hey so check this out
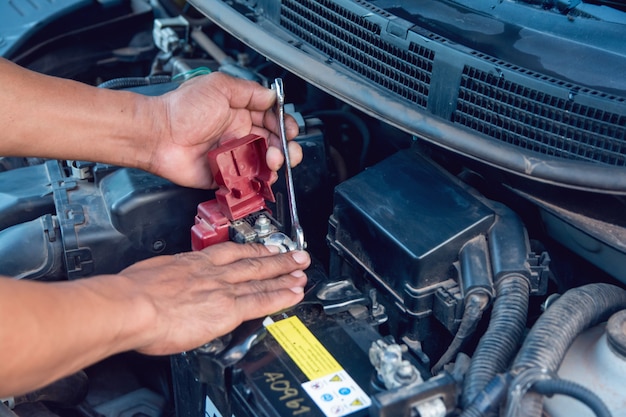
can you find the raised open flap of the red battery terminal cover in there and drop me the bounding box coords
[208,134,275,220]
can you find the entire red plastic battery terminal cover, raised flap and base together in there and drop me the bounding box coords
[191,134,275,250]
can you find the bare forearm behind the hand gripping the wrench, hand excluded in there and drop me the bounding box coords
[0,59,162,168]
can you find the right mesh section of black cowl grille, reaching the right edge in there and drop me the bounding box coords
[453,66,626,166]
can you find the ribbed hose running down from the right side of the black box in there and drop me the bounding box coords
[461,274,530,409]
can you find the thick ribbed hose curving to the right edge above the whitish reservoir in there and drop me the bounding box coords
[512,283,626,417]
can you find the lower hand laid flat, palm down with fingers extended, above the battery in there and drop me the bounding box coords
[120,242,310,355]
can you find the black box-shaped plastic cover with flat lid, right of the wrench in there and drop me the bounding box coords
[329,150,494,302]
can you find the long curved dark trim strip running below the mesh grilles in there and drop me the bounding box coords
[190,0,626,194]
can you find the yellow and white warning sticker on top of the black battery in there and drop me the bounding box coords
[264,316,371,417]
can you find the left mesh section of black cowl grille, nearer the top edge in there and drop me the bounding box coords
[280,0,434,108]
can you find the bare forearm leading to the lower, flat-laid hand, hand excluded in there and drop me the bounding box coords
[0,276,153,398]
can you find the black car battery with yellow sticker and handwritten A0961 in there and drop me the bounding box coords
[201,303,380,417]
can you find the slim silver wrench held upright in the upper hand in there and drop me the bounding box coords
[272,78,306,250]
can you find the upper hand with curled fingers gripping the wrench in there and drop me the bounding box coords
[148,72,302,188]
